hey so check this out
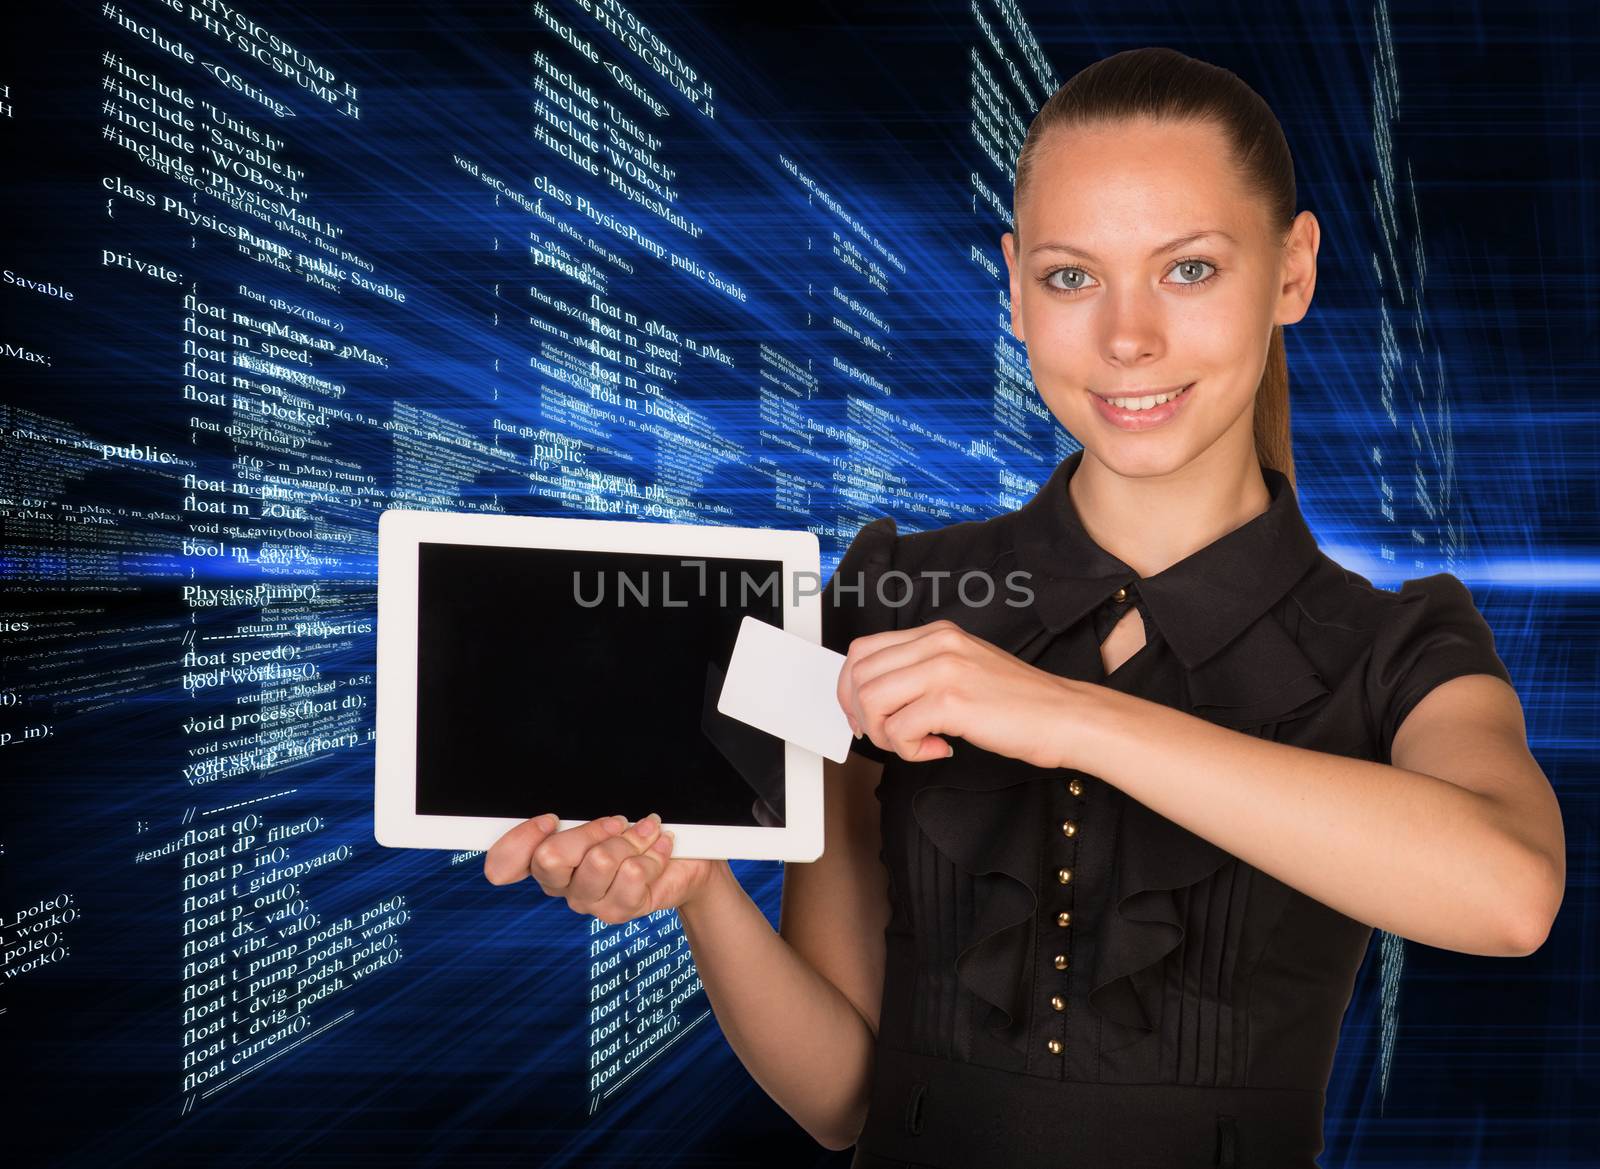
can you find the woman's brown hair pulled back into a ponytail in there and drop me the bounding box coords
[1011,46,1294,485]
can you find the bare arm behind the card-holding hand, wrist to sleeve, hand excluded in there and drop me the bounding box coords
[1067,675,1566,956]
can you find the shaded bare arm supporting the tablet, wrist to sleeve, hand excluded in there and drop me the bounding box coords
[678,753,890,1150]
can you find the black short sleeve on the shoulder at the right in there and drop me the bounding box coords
[1368,573,1510,763]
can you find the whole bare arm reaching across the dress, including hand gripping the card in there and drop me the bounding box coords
[838,619,1566,956]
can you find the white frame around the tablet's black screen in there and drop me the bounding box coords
[373,509,822,862]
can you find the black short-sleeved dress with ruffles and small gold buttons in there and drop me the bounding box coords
[822,451,1510,1169]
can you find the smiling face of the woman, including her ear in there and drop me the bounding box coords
[1000,120,1318,475]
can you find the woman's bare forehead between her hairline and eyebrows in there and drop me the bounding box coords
[1018,120,1256,251]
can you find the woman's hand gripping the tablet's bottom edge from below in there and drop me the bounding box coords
[483,812,728,924]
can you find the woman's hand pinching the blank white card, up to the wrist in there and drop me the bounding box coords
[838,619,1085,768]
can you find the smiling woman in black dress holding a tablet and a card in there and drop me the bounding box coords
[485,48,1565,1169]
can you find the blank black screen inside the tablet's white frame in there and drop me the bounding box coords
[416,542,792,827]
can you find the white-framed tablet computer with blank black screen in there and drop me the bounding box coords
[373,509,822,862]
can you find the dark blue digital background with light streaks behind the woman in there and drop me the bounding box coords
[0,0,1600,1166]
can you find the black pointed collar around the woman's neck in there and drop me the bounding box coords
[1016,449,1318,670]
